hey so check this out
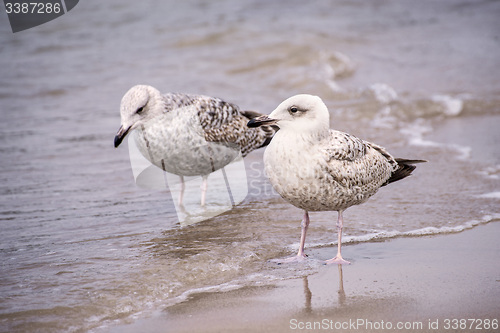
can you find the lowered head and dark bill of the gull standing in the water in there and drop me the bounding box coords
[115,85,164,148]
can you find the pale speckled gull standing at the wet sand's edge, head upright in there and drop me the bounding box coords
[248,94,425,264]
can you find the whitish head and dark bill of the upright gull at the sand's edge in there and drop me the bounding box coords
[248,94,330,133]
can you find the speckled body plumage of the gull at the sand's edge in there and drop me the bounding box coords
[264,130,398,211]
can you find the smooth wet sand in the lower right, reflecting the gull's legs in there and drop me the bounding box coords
[110,222,500,333]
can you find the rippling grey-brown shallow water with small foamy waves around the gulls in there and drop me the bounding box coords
[0,0,500,332]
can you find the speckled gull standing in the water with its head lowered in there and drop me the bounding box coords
[114,85,276,206]
